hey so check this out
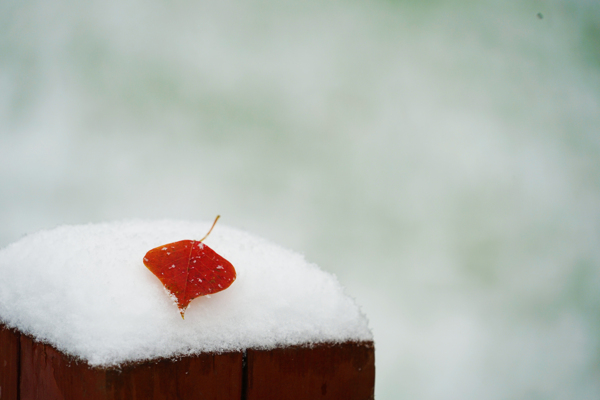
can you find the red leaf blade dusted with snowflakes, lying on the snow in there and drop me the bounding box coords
[144,241,236,318]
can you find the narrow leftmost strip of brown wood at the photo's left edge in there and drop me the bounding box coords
[0,324,20,400]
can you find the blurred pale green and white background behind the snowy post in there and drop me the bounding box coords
[0,0,600,400]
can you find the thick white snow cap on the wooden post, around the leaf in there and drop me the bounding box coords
[0,221,372,366]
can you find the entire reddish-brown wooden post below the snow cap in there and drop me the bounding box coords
[0,325,375,400]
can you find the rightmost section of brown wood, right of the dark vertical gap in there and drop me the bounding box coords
[245,342,375,400]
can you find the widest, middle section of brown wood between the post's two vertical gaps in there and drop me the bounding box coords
[20,336,243,400]
